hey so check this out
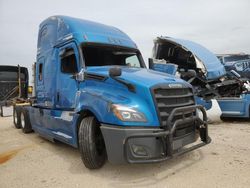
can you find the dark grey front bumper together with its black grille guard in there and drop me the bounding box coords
[101,105,211,164]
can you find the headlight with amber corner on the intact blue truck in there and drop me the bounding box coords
[111,104,147,122]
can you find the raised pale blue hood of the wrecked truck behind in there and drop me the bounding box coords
[159,37,226,80]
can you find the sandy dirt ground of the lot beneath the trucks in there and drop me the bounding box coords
[0,117,250,188]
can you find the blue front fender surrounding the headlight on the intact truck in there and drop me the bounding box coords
[76,76,159,126]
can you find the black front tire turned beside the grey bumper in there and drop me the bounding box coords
[78,116,106,169]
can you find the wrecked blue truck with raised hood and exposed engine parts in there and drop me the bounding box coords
[149,37,249,117]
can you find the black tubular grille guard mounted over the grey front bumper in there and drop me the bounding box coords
[123,105,211,163]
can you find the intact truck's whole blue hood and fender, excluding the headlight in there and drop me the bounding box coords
[73,66,192,126]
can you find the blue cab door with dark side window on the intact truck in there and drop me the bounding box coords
[56,42,79,110]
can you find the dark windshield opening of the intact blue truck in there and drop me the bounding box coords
[82,46,145,68]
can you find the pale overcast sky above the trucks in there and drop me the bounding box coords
[0,0,250,71]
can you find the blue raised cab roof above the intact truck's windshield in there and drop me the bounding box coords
[38,16,137,53]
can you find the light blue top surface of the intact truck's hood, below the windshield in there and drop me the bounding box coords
[87,66,192,88]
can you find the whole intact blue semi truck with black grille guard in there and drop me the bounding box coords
[13,16,211,169]
